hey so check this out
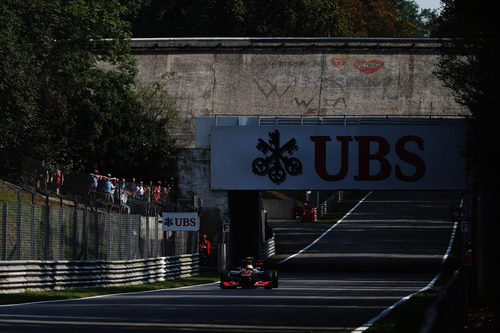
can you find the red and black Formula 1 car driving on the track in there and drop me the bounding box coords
[220,258,278,289]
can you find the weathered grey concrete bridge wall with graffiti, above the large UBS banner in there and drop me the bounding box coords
[132,38,468,148]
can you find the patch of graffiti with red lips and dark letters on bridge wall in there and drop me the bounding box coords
[253,55,393,116]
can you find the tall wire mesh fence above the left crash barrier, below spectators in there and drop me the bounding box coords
[0,198,198,261]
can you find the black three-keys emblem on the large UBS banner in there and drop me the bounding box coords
[252,130,302,185]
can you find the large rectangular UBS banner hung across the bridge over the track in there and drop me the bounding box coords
[210,120,465,190]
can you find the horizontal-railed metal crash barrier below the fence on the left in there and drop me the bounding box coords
[0,254,199,293]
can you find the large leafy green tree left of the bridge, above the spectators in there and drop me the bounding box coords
[0,0,179,176]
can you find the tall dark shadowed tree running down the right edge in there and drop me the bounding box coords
[437,0,500,315]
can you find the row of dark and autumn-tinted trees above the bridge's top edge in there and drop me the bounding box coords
[133,0,434,37]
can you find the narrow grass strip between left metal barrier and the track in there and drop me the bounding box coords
[0,269,220,305]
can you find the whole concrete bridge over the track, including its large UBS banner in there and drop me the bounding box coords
[132,38,469,264]
